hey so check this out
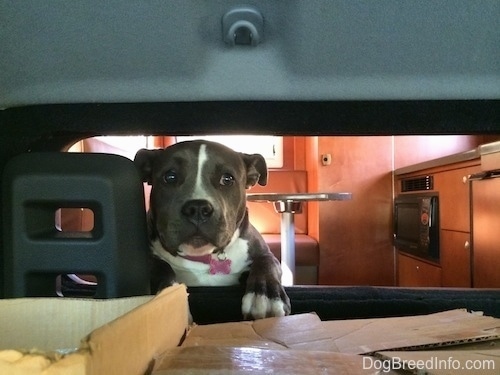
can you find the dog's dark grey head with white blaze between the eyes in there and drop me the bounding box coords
[134,141,267,256]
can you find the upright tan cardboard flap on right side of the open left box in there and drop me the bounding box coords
[84,284,189,375]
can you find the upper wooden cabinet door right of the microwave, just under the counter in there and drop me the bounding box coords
[434,166,479,232]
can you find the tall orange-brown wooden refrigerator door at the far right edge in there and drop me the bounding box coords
[472,178,500,288]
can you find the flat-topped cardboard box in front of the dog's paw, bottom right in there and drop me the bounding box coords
[153,310,500,375]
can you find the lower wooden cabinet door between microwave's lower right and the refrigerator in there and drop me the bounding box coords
[440,230,472,288]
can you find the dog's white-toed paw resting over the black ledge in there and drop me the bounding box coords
[241,291,290,320]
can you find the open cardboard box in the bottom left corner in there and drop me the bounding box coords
[0,285,188,375]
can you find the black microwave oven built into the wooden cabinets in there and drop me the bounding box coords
[394,193,439,262]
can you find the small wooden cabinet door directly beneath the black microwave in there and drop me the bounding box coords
[398,253,441,287]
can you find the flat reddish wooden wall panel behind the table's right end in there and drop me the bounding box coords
[311,137,395,285]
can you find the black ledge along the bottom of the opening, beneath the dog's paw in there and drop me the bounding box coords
[188,286,500,324]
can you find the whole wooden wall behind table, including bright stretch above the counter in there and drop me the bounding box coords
[305,135,500,285]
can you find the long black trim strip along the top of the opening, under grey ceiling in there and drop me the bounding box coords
[0,100,500,142]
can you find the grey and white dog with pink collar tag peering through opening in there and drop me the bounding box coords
[134,140,291,319]
